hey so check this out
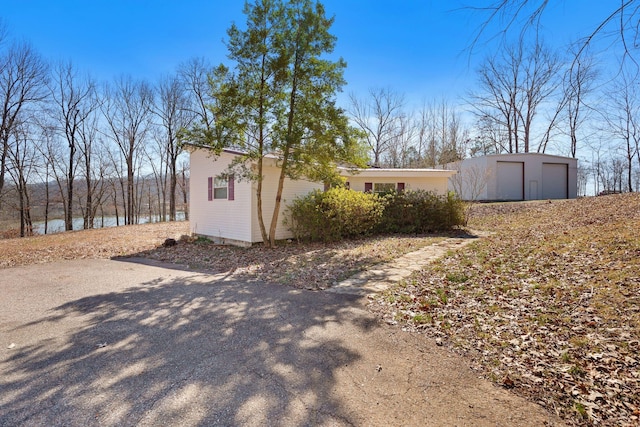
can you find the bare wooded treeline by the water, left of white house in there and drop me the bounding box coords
[0,26,216,236]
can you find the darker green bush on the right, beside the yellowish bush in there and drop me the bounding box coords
[376,190,464,234]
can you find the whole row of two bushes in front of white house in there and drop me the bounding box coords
[287,188,464,242]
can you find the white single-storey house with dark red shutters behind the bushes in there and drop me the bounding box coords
[189,147,456,246]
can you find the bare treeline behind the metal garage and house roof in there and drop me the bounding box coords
[349,39,640,195]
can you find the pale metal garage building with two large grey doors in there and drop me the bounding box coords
[445,153,578,201]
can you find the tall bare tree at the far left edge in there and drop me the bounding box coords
[0,43,48,212]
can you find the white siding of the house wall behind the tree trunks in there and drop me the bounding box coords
[251,165,324,243]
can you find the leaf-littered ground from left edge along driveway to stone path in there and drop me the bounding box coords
[0,222,444,289]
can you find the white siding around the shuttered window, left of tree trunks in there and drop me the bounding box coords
[189,149,253,243]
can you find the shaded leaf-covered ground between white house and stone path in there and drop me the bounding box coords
[142,236,443,289]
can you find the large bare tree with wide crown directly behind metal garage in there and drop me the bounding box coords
[470,43,560,153]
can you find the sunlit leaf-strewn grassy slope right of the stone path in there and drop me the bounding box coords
[370,194,640,426]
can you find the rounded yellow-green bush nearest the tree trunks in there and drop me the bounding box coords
[287,188,384,242]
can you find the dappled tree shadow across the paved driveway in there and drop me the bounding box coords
[0,261,373,426]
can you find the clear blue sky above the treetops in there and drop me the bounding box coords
[0,0,611,105]
